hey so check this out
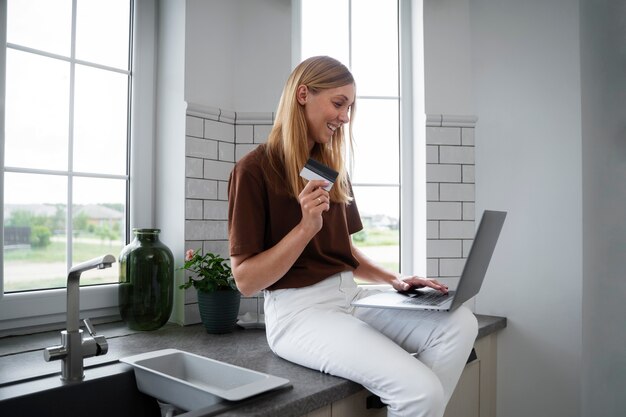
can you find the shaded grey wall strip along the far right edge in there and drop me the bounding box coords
[580,0,626,416]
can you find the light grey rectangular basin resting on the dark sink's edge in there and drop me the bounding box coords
[120,349,289,411]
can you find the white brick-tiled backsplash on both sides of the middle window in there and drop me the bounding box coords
[185,105,476,324]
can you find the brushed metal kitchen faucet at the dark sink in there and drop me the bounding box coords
[43,255,115,381]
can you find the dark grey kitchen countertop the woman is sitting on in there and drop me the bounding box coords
[0,315,506,417]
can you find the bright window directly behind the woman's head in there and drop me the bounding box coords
[300,0,405,271]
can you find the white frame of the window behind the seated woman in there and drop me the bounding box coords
[291,0,426,277]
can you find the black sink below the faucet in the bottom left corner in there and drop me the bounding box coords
[0,362,161,417]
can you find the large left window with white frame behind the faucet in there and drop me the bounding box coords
[0,0,156,332]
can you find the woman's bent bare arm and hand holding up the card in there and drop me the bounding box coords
[230,180,330,296]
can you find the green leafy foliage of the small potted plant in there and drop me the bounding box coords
[179,249,237,292]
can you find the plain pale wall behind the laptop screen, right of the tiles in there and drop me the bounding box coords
[466,0,582,417]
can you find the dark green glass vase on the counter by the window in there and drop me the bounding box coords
[119,229,174,330]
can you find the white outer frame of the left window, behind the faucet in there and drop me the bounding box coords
[0,0,158,336]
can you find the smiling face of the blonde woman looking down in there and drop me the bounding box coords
[297,84,356,150]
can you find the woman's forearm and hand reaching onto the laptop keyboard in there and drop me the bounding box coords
[352,244,448,294]
